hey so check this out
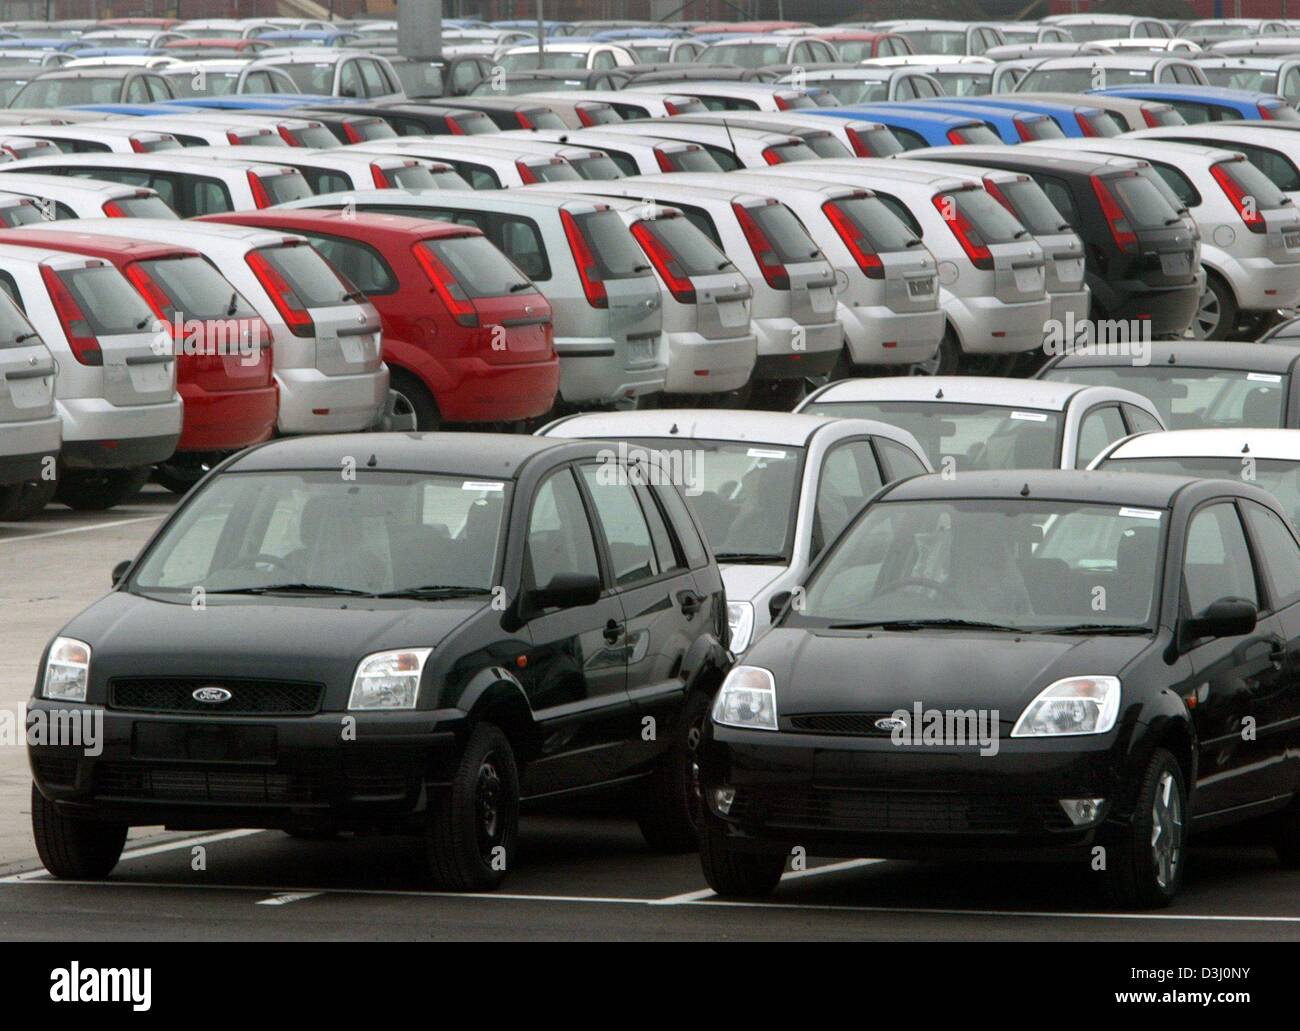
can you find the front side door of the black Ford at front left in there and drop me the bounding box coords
[517,467,633,797]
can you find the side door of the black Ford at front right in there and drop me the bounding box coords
[1182,499,1286,818]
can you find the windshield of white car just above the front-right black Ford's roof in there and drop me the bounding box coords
[801,400,1061,471]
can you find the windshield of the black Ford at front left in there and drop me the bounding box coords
[131,469,507,595]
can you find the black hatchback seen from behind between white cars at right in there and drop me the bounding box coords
[913,147,1201,337]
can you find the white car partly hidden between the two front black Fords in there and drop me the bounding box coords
[538,410,931,655]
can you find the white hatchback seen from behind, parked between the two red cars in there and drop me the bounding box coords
[38,219,389,434]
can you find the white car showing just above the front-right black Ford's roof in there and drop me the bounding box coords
[796,376,1165,475]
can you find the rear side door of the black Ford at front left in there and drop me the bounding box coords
[579,456,705,772]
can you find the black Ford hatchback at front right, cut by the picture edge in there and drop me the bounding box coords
[699,471,1300,906]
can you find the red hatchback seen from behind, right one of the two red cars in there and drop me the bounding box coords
[202,209,560,429]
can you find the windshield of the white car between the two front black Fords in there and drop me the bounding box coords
[637,438,803,566]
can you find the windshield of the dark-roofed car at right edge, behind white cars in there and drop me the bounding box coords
[1044,364,1288,429]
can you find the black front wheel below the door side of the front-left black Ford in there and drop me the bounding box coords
[425,723,519,892]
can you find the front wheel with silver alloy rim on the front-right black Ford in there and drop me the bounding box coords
[1102,749,1188,909]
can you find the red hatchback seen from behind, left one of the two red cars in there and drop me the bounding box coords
[4,222,280,493]
